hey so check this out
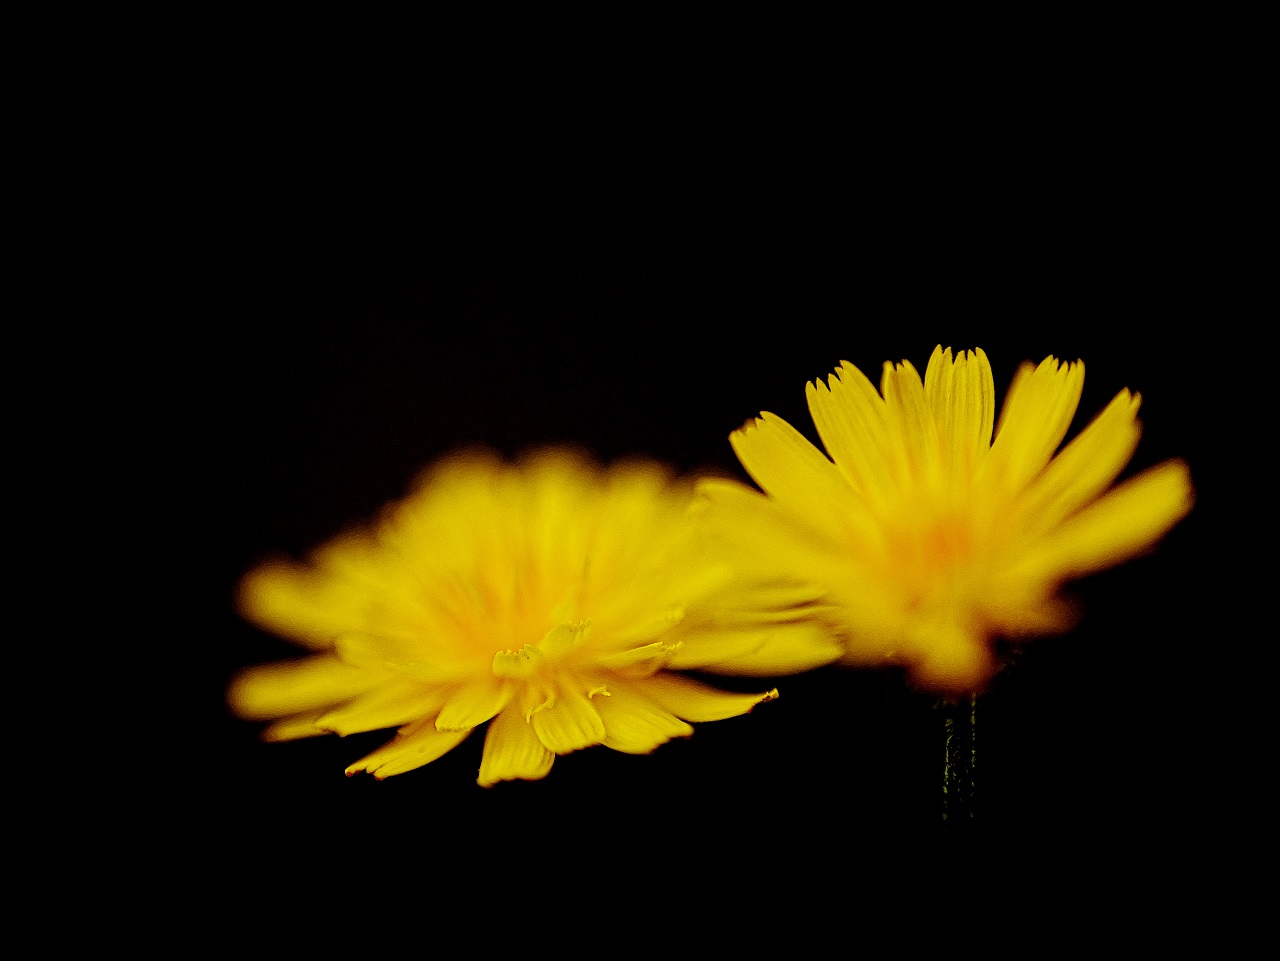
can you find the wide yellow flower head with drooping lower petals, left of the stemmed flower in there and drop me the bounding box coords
[229,450,831,786]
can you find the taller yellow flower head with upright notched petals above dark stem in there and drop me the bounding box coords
[701,347,1193,696]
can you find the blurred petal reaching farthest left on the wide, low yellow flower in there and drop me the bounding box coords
[227,654,385,720]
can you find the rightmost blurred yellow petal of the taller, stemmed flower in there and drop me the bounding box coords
[1010,461,1194,580]
